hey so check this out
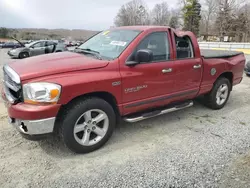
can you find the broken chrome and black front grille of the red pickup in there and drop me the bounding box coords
[3,65,21,103]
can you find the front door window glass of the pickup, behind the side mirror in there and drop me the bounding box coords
[131,32,170,62]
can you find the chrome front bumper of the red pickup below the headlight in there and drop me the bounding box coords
[9,117,56,135]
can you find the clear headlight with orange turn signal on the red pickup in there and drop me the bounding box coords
[23,82,61,104]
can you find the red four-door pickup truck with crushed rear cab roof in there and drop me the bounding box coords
[2,26,245,153]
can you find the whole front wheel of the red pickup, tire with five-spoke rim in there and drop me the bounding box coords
[59,98,116,153]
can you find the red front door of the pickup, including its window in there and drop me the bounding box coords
[120,31,175,114]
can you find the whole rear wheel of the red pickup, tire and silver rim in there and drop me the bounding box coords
[204,77,232,110]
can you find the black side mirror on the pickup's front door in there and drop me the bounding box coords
[126,49,153,66]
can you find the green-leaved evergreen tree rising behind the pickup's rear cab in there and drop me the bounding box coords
[182,0,201,35]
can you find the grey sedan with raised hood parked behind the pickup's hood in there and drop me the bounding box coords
[8,40,67,59]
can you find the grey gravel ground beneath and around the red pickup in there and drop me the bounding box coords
[0,50,250,188]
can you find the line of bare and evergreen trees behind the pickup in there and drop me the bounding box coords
[114,0,250,42]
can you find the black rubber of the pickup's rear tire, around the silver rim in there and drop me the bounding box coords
[207,78,232,110]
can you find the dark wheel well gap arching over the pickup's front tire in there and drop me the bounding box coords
[54,92,120,131]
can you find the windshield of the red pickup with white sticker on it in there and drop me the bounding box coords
[78,30,141,59]
